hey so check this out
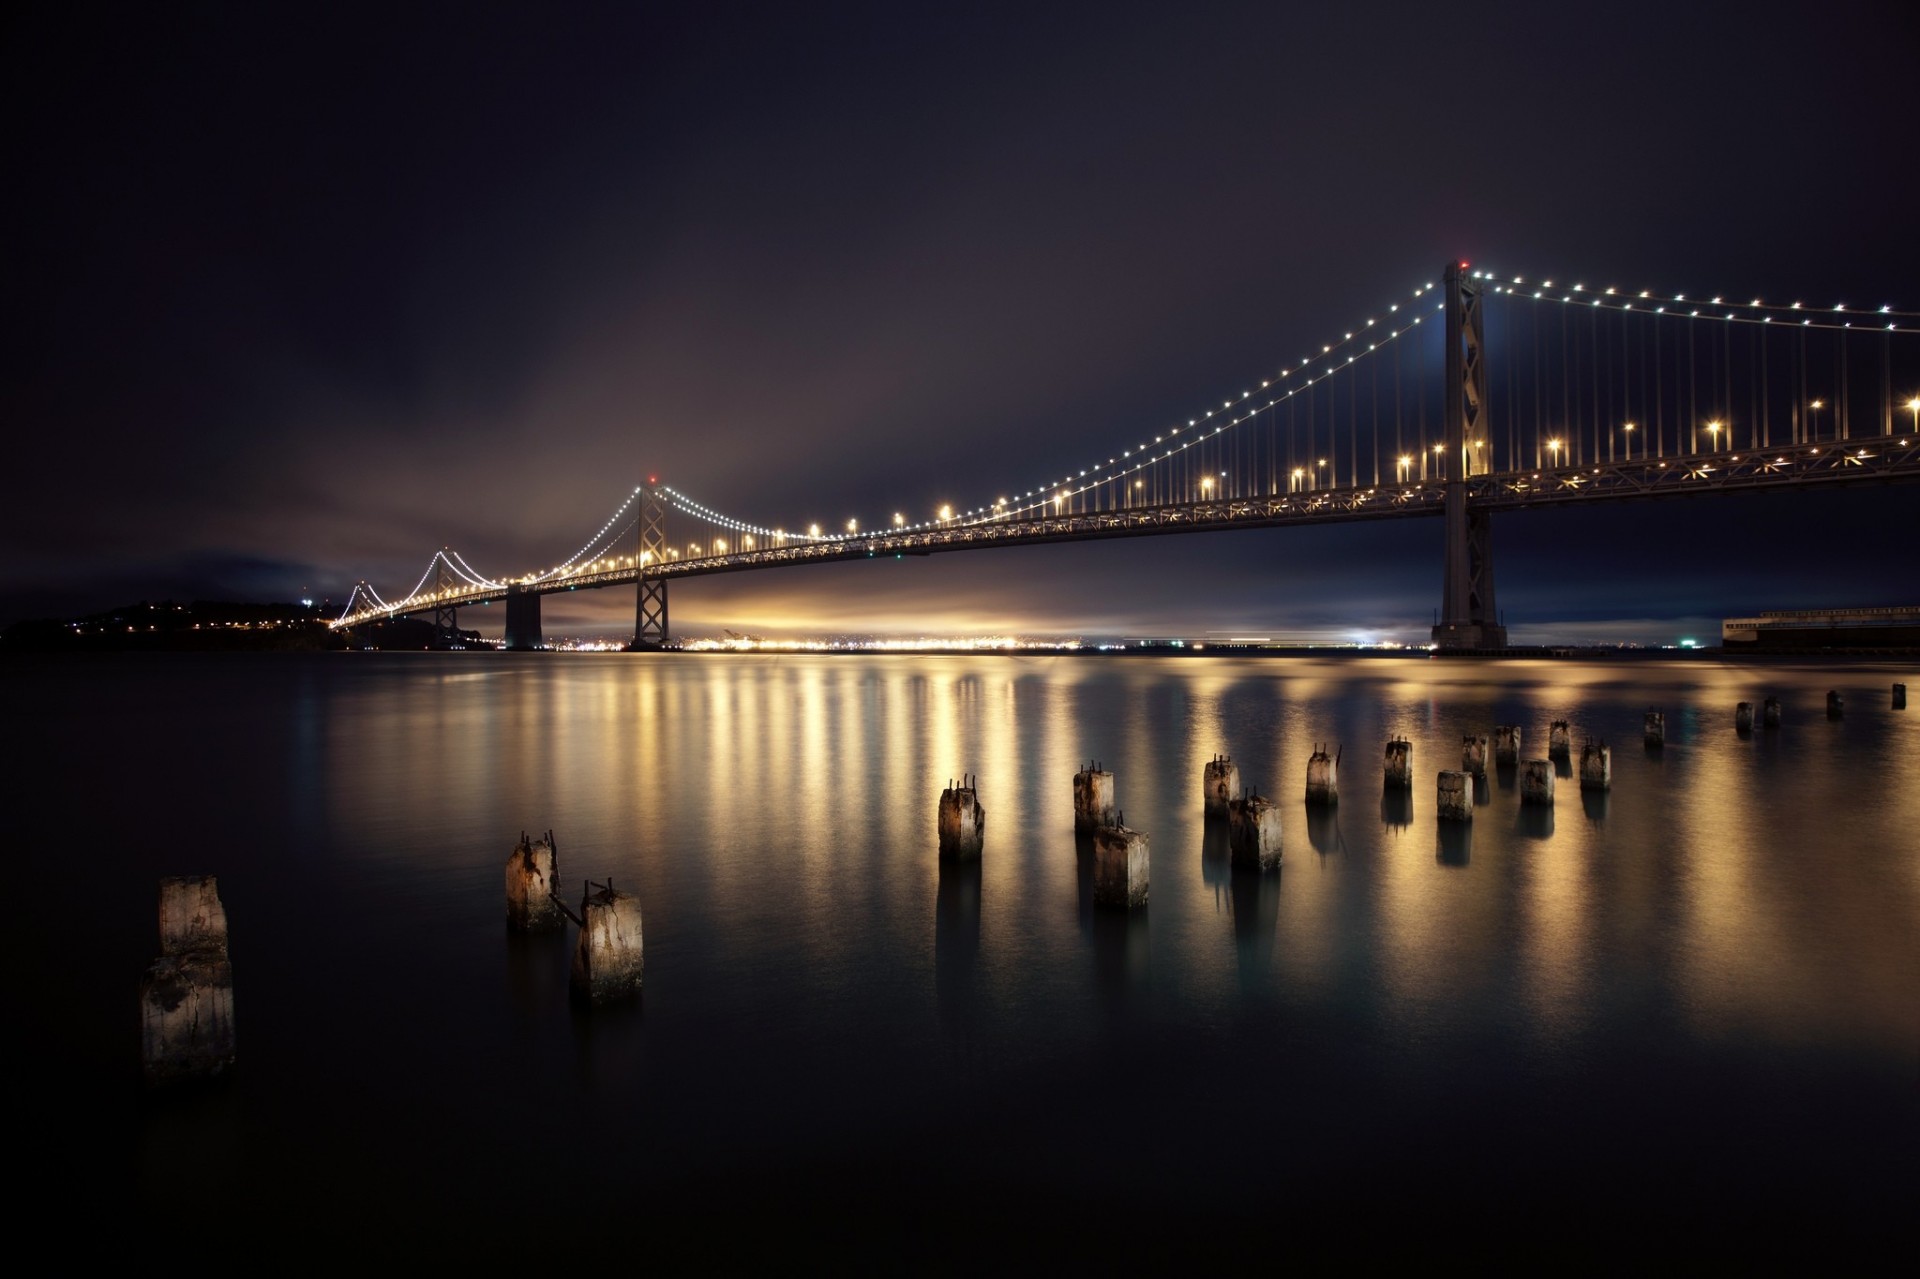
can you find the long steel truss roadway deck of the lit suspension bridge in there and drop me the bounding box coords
[334,436,1920,630]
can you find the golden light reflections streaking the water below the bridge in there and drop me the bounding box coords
[326,655,1920,1054]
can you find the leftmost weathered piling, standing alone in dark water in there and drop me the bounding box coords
[140,876,234,1083]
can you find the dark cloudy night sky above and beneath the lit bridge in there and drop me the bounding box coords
[0,0,1920,640]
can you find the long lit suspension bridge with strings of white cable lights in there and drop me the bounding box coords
[332,263,1920,649]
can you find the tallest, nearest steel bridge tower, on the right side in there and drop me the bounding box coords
[1432,261,1507,649]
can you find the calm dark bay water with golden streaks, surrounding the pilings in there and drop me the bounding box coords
[0,655,1920,1269]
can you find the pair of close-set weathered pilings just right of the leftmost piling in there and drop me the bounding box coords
[507,830,645,1004]
